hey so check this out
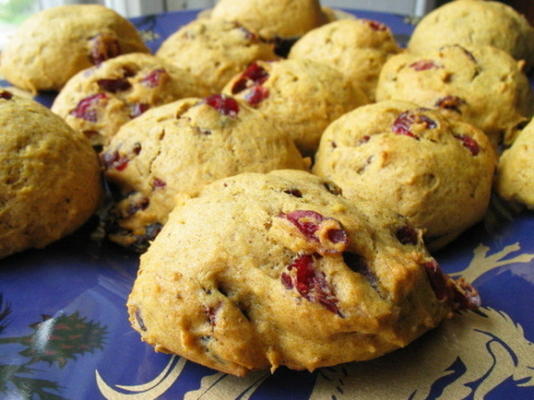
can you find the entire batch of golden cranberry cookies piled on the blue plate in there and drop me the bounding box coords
[0,0,534,375]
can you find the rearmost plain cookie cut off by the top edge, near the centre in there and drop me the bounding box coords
[211,0,328,39]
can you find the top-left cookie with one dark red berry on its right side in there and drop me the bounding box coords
[0,4,149,92]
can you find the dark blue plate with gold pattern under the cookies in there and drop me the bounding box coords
[0,8,534,400]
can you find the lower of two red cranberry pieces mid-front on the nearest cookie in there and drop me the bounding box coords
[280,254,343,318]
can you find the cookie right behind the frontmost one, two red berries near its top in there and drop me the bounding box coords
[313,101,496,249]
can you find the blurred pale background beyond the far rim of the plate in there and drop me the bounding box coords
[0,0,534,49]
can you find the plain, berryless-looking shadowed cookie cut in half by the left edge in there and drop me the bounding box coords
[0,90,101,258]
